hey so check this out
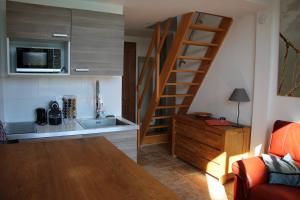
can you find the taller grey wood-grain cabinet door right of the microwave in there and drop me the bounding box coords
[71,10,124,76]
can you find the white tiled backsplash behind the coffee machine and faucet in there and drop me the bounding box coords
[4,77,122,122]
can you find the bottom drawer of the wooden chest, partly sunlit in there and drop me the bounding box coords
[175,146,224,178]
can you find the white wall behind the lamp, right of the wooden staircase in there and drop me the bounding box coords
[189,15,255,125]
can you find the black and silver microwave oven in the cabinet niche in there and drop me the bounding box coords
[16,47,62,73]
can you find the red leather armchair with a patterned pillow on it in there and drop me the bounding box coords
[232,121,300,200]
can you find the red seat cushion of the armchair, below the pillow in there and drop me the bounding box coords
[249,184,300,200]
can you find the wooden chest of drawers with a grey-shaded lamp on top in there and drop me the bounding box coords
[172,115,251,183]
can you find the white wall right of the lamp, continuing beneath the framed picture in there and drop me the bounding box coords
[251,0,300,155]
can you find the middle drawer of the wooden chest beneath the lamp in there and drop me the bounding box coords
[175,135,225,165]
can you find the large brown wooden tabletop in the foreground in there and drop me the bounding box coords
[0,137,178,200]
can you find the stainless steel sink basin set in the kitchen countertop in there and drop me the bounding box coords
[77,117,129,129]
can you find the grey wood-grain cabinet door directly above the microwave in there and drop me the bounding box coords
[7,1,71,41]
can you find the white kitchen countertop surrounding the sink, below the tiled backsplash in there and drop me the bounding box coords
[7,117,138,140]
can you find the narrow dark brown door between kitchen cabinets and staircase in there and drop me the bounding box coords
[122,42,136,122]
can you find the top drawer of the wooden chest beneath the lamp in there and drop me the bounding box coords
[175,122,224,150]
